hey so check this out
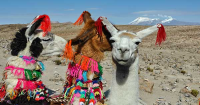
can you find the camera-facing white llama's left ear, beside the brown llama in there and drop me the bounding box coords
[100,17,118,36]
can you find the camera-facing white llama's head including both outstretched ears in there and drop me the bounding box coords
[101,17,166,66]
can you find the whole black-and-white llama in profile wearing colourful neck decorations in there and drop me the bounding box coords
[0,15,66,105]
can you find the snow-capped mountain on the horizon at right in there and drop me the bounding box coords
[129,17,200,25]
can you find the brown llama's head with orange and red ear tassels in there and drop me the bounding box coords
[69,11,111,62]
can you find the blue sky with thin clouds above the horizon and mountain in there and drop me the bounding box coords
[0,0,200,24]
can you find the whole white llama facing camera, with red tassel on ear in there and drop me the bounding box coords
[101,17,166,105]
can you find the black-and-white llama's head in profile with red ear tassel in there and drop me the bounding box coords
[11,15,66,58]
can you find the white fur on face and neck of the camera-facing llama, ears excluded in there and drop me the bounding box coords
[109,31,141,105]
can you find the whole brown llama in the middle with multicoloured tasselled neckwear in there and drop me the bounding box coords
[49,11,111,105]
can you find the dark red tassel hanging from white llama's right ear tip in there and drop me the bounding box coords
[155,24,166,45]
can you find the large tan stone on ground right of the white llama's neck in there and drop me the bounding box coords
[139,79,154,93]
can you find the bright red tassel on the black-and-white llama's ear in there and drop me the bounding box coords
[32,14,51,36]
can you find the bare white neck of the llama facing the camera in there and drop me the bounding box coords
[109,56,139,105]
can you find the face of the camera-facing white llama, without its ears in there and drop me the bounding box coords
[110,31,141,65]
